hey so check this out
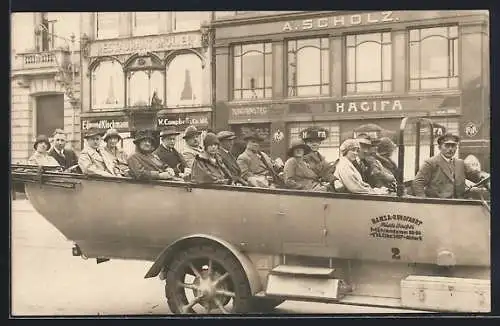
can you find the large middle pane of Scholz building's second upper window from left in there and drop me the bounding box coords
[297,47,321,85]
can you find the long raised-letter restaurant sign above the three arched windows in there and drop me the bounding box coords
[90,33,201,57]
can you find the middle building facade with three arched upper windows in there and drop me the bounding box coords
[81,11,212,153]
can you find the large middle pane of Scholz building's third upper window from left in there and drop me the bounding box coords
[356,42,382,82]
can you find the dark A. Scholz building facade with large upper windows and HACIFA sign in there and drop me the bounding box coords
[212,10,490,176]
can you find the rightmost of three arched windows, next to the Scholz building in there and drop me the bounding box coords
[166,54,203,107]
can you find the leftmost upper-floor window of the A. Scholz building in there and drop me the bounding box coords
[233,43,272,100]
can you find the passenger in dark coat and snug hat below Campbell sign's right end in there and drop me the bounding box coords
[191,133,231,184]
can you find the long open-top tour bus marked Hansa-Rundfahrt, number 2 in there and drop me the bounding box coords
[12,118,490,313]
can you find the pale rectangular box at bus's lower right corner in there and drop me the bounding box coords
[401,275,491,312]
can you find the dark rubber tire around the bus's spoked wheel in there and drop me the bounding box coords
[165,245,252,314]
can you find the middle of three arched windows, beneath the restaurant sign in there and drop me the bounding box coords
[125,57,165,106]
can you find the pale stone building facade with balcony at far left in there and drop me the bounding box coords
[11,12,80,163]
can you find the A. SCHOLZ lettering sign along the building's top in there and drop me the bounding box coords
[283,11,399,32]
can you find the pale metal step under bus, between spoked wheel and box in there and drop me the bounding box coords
[265,265,350,301]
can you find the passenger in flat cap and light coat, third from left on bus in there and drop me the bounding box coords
[78,129,116,177]
